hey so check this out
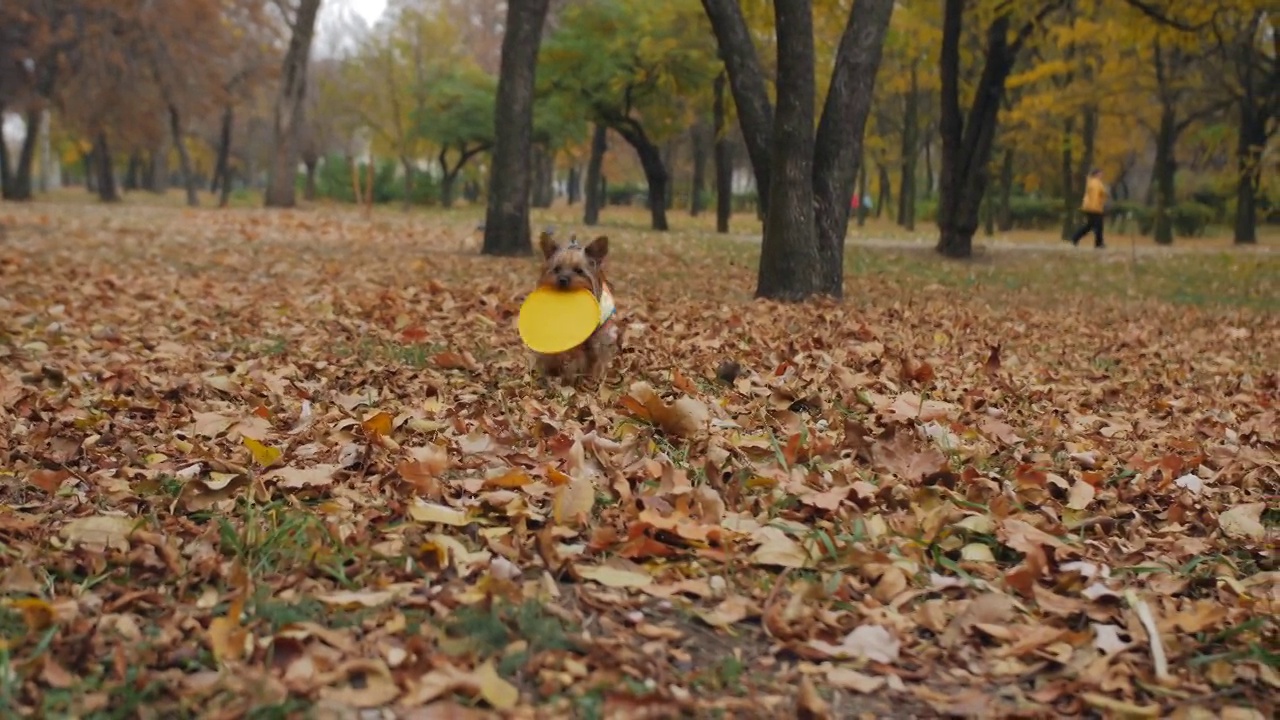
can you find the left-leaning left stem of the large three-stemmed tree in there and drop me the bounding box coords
[703,0,774,219]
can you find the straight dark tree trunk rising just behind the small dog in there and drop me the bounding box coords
[480,0,549,255]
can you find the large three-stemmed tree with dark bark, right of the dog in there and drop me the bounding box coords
[703,0,893,300]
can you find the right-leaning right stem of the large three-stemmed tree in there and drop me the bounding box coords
[810,0,893,297]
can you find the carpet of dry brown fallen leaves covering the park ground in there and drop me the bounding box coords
[0,205,1280,720]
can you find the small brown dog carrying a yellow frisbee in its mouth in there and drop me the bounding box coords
[538,232,622,382]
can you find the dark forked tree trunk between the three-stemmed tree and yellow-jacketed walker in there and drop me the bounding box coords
[937,0,1044,258]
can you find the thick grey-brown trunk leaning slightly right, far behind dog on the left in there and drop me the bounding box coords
[265,0,320,208]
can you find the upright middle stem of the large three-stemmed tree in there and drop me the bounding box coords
[755,0,819,301]
